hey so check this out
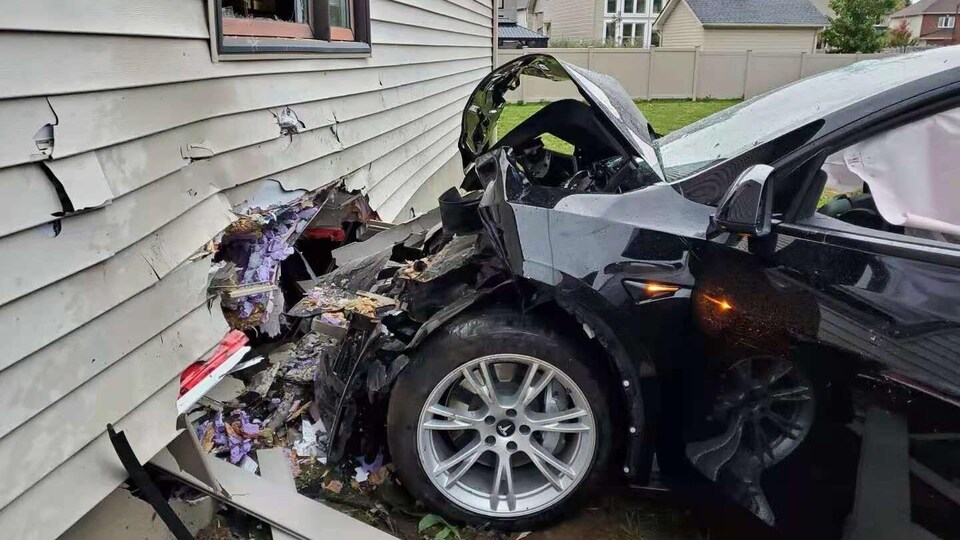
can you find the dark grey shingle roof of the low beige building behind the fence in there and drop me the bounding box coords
[677,0,828,26]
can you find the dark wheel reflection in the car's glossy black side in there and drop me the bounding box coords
[715,356,816,467]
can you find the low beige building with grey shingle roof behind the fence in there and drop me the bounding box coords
[655,0,829,52]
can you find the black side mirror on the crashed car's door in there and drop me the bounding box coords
[713,165,773,236]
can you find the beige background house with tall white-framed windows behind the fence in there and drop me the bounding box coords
[527,0,664,47]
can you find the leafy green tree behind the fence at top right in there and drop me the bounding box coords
[823,0,897,53]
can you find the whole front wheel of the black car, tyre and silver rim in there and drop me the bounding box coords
[387,310,611,530]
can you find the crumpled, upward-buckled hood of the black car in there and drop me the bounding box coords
[460,54,663,178]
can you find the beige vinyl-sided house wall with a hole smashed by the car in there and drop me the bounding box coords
[0,0,495,540]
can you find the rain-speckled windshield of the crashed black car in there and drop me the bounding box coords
[656,48,960,182]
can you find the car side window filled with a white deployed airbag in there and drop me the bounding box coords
[817,109,960,244]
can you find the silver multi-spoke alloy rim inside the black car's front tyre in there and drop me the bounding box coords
[417,354,596,517]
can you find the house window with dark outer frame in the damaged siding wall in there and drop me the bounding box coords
[216,0,370,59]
